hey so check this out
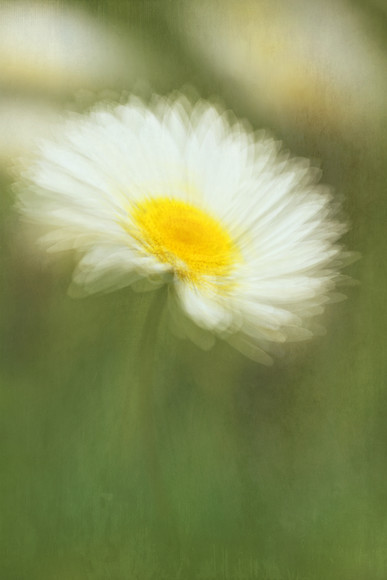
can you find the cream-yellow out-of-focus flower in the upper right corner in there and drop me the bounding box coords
[176,0,387,132]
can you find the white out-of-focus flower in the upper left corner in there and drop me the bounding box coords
[0,2,141,94]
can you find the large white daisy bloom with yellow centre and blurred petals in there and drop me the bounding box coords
[20,96,344,361]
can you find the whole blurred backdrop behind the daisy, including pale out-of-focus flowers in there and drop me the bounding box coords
[0,0,387,580]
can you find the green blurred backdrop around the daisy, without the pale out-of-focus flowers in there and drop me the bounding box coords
[0,1,387,580]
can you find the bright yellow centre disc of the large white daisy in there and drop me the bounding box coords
[131,197,240,284]
